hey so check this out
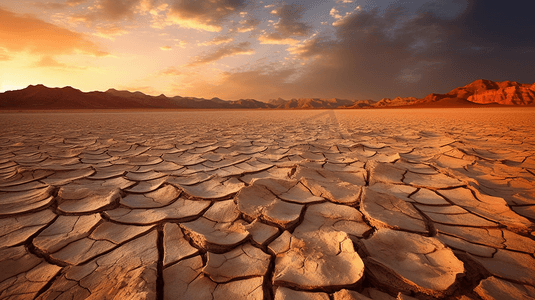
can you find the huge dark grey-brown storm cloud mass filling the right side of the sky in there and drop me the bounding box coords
[200,1,535,100]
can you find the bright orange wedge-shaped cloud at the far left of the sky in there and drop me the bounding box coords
[0,8,109,56]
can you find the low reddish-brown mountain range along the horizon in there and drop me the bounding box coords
[0,79,535,110]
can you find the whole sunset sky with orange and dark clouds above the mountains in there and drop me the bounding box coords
[0,0,535,101]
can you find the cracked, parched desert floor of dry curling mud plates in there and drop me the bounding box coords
[0,108,535,300]
